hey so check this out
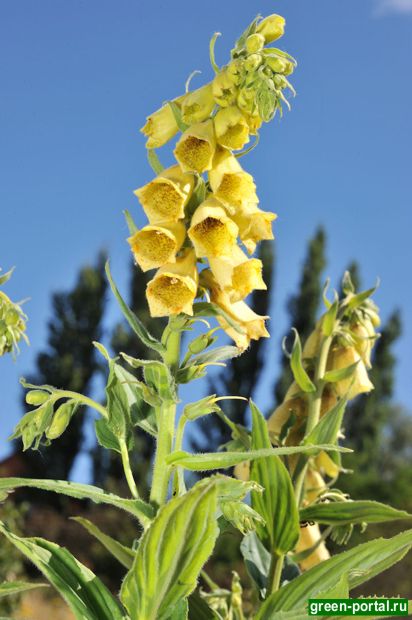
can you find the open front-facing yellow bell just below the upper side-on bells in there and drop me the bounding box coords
[173,120,216,174]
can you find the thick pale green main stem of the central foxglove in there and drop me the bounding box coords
[150,318,181,506]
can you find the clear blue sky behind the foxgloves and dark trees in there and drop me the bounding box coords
[0,0,412,474]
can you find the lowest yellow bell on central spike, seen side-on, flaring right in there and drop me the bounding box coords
[201,269,269,351]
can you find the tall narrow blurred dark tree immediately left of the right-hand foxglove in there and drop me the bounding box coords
[274,228,326,406]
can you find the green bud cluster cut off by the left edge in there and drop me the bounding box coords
[0,270,28,357]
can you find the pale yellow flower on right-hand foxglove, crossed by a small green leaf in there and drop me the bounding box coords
[327,346,373,400]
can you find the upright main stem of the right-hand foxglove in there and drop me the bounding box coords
[295,336,332,508]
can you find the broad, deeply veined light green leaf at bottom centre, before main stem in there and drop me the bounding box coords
[121,479,219,620]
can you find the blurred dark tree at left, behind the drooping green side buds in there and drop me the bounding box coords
[17,254,106,482]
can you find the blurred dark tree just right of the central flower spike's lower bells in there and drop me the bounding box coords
[193,241,274,450]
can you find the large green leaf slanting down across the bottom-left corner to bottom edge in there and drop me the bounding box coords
[0,522,126,620]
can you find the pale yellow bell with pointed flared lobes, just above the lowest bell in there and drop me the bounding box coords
[209,245,267,302]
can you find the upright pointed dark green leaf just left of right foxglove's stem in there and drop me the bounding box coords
[250,401,300,555]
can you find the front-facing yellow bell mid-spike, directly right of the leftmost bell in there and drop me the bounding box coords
[188,197,238,258]
